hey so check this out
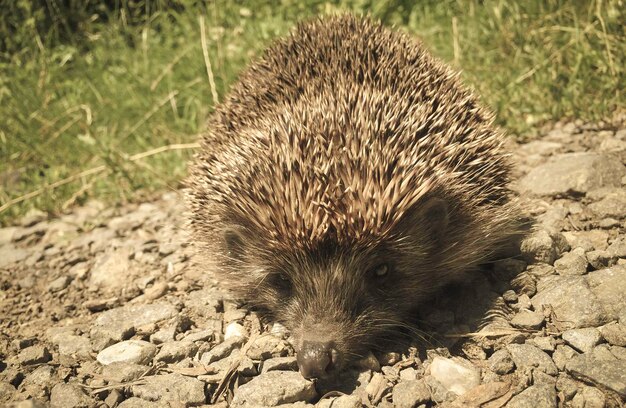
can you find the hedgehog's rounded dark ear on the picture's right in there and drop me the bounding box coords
[399,197,449,244]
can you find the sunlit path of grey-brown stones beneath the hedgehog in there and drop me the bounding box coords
[0,119,626,408]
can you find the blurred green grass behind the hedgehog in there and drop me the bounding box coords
[0,0,626,224]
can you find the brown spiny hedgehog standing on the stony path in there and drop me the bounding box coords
[188,15,515,378]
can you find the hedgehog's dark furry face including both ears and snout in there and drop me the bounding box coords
[219,199,448,378]
